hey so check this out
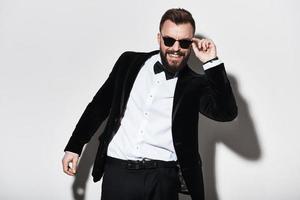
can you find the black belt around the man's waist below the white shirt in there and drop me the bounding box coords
[106,156,177,169]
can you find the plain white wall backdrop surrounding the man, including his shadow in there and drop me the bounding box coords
[0,0,300,200]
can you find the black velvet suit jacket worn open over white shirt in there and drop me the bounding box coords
[64,51,237,200]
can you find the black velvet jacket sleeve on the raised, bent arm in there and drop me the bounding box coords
[199,63,238,122]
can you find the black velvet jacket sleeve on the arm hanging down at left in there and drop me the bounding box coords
[64,52,126,155]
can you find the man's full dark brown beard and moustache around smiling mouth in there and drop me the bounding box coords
[159,48,190,72]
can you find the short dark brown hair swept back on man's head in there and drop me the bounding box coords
[159,8,196,33]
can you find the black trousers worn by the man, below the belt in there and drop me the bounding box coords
[101,157,180,200]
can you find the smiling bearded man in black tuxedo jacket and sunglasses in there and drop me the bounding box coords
[62,9,237,200]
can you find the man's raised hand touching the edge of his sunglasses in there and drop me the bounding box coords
[192,38,217,63]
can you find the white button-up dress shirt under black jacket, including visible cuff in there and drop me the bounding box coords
[107,54,220,161]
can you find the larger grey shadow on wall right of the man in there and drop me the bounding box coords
[180,41,262,200]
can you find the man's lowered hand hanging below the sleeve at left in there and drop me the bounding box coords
[62,151,79,176]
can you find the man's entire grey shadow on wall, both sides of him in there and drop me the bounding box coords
[72,36,262,200]
